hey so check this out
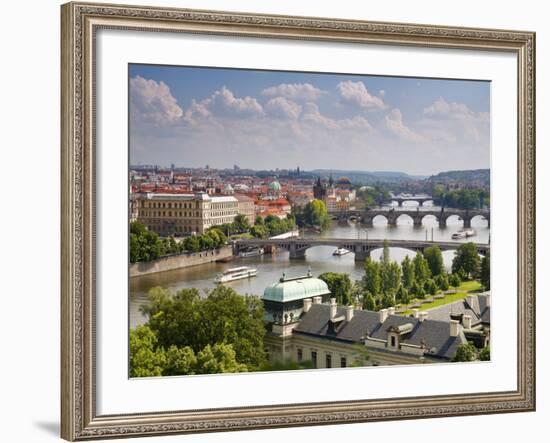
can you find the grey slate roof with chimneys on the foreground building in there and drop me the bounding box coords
[293,304,466,359]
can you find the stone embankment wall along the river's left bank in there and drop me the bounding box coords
[130,246,233,277]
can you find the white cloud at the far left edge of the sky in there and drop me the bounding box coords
[130,76,183,126]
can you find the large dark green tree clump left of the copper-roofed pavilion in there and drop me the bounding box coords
[142,286,265,370]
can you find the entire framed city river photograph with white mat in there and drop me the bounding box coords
[61,3,535,441]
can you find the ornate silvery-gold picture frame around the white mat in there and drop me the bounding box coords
[61,3,535,441]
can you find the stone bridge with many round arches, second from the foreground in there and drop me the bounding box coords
[336,208,491,228]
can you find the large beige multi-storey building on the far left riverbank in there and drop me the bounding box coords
[138,192,239,236]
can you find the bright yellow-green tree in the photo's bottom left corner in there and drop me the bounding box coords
[130,325,166,377]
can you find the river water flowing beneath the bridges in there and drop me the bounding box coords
[130,203,489,328]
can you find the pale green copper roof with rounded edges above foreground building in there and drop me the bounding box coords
[262,275,330,303]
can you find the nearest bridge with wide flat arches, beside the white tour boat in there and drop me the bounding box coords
[233,237,490,261]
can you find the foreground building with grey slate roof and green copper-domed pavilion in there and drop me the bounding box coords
[264,276,489,368]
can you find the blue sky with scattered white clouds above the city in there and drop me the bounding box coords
[129,64,490,175]
